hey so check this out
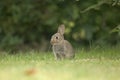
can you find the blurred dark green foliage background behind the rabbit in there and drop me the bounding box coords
[0,0,120,52]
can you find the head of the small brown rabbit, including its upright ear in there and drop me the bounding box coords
[50,24,65,45]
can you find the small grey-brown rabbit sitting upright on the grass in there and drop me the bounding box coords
[50,24,75,60]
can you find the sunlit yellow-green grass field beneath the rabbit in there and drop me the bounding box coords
[0,46,120,80]
